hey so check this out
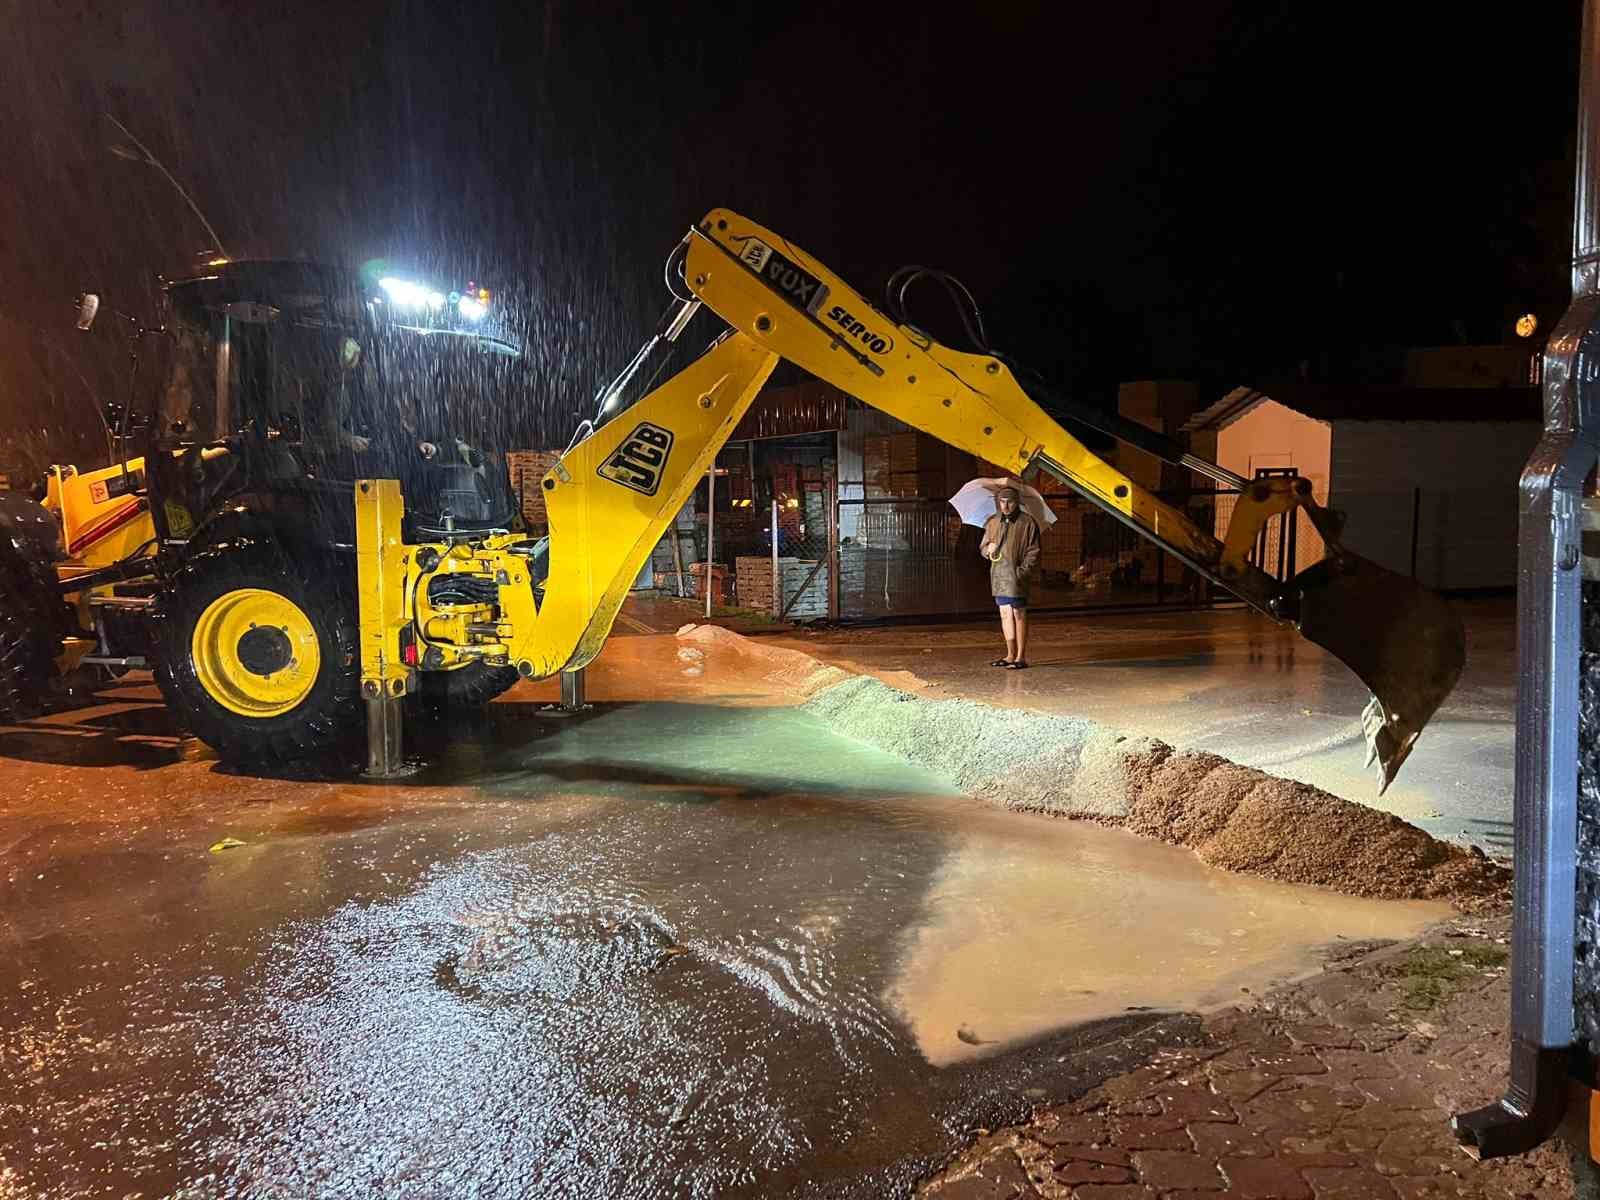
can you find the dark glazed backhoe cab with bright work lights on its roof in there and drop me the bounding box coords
[146,261,520,544]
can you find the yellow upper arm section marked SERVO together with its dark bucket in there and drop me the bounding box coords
[683,210,1466,787]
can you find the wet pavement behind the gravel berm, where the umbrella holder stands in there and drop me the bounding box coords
[763,598,1517,854]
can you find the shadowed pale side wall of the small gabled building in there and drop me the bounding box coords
[1331,421,1539,587]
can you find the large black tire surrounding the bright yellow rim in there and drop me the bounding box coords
[155,541,365,765]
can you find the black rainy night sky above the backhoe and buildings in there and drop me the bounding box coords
[0,0,1579,467]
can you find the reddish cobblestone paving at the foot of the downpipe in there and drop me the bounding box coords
[918,920,1573,1200]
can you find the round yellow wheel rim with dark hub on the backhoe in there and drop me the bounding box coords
[189,587,322,717]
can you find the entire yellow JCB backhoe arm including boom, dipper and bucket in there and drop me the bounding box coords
[358,210,1464,786]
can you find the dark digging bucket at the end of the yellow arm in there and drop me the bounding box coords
[1285,550,1467,795]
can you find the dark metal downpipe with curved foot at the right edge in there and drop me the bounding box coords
[1453,0,1600,1158]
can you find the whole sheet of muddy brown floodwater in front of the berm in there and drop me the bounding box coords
[0,691,1443,1198]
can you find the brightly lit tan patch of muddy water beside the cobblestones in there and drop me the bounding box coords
[886,806,1450,1066]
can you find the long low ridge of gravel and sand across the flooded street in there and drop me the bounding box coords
[678,626,1510,910]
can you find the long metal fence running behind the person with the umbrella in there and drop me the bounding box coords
[675,476,1517,621]
